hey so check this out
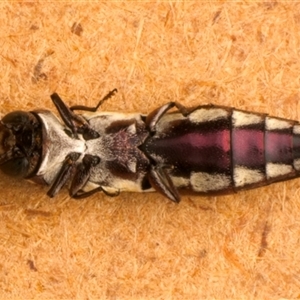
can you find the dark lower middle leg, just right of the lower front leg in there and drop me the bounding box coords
[70,154,100,197]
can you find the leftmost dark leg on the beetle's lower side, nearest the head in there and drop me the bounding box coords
[47,152,80,198]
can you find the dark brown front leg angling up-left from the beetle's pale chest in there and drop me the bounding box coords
[51,93,99,140]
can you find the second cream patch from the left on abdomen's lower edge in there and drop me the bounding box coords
[233,166,265,187]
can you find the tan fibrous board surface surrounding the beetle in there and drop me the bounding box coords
[0,1,300,299]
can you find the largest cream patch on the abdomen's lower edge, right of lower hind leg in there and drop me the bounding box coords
[191,172,231,192]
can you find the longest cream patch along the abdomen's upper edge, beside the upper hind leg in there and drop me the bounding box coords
[188,107,229,123]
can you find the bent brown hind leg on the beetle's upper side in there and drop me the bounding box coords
[145,102,190,132]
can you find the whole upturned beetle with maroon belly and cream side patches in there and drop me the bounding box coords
[0,89,300,202]
